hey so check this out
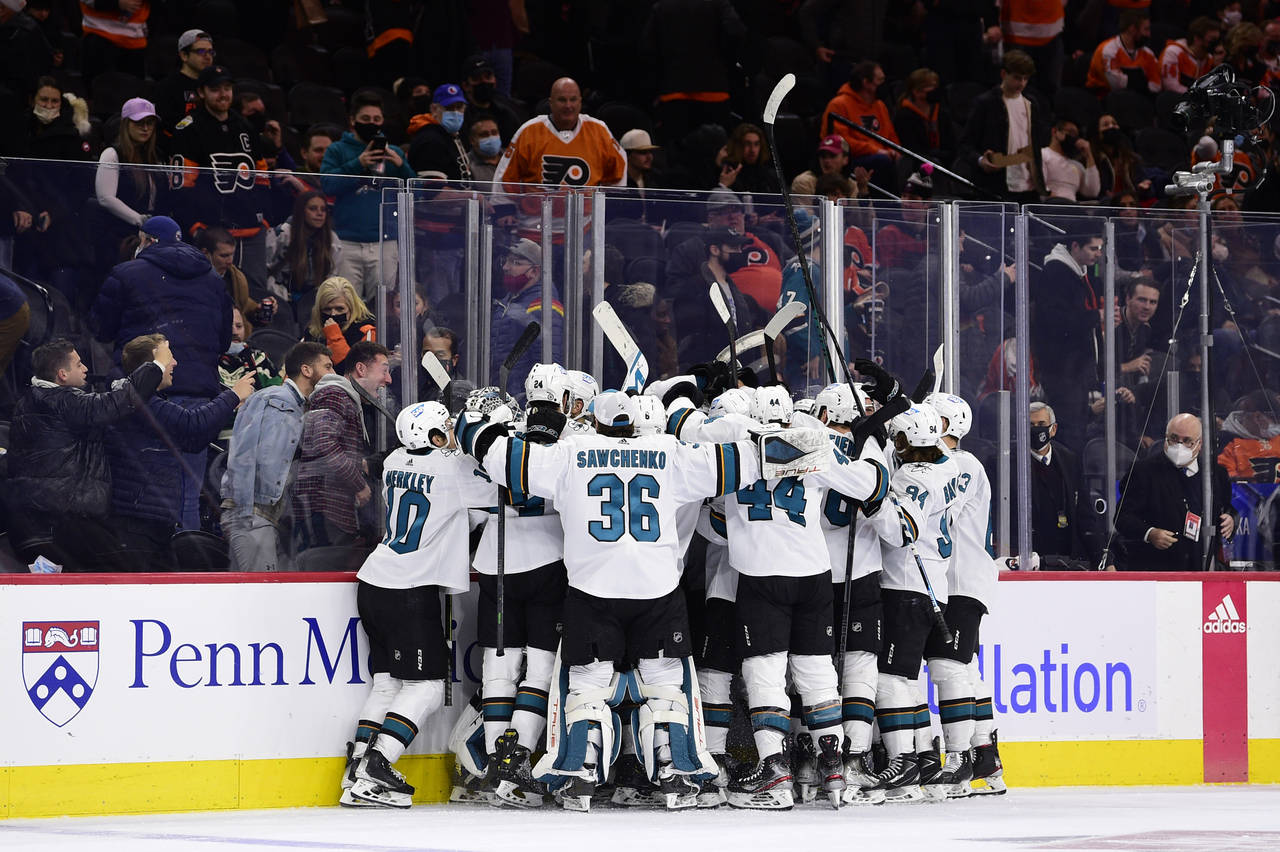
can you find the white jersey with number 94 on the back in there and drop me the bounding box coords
[881,455,960,603]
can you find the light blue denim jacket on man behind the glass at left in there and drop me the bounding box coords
[223,381,303,517]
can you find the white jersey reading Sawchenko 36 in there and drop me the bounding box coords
[484,435,759,600]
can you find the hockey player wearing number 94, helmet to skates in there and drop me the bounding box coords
[876,403,960,802]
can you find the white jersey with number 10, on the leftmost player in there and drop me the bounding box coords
[356,448,497,592]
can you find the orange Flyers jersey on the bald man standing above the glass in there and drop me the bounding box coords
[493,115,627,187]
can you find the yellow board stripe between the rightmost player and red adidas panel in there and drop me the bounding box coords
[1000,739,1204,792]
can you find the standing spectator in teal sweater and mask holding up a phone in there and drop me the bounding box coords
[320,92,416,302]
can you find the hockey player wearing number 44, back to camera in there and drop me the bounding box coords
[667,386,888,810]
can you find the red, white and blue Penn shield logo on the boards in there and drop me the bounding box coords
[22,620,99,728]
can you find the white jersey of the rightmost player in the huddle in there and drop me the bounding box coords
[947,448,1000,606]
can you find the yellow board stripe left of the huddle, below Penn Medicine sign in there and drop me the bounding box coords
[0,755,453,819]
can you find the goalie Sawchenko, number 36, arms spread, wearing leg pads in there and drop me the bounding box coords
[458,393,783,810]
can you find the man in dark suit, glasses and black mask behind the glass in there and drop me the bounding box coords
[1030,403,1093,564]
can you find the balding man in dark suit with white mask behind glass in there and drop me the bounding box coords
[1116,413,1235,571]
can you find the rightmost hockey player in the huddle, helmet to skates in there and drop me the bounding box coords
[924,393,1004,798]
